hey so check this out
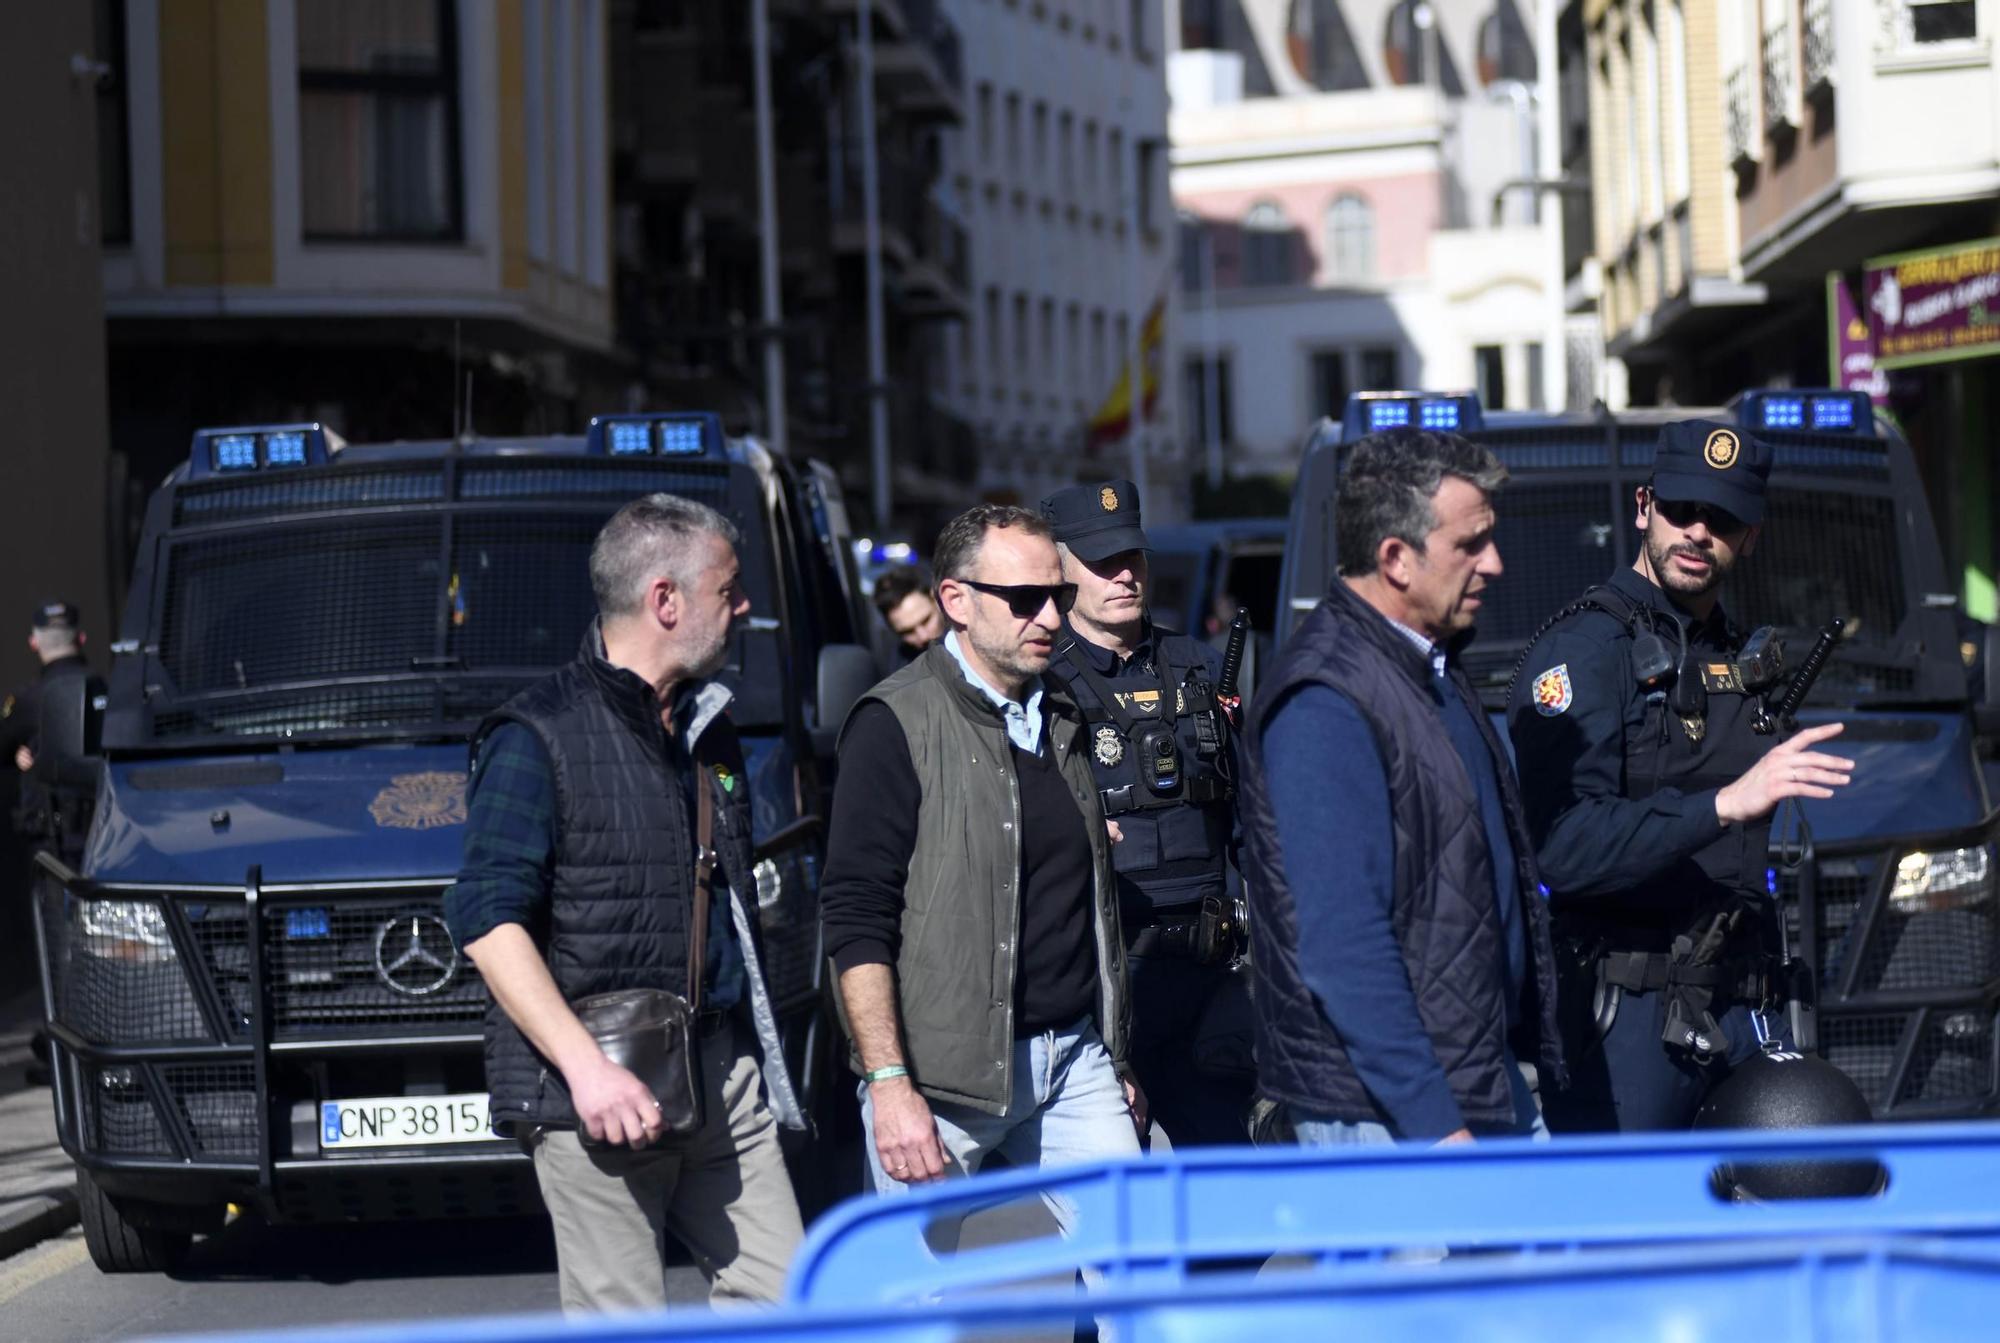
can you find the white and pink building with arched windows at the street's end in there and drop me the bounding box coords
[1172,0,1566,483]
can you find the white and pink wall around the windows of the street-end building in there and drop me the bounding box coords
[1172,0,1562,474]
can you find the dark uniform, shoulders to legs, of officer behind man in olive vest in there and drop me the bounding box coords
[1050,630,1250,1147]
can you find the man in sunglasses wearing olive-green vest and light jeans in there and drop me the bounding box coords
[820,504,1144,1229]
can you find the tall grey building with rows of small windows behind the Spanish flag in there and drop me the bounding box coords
[932,0,1186,520]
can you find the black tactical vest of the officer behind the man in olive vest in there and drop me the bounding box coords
[1048,628,1232,911]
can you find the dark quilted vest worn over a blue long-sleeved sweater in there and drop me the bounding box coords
[1242,582,1566,1123]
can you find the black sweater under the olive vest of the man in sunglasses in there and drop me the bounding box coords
[820,699,1098,1035]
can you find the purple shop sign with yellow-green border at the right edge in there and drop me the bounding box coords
[1862,238,2000,368]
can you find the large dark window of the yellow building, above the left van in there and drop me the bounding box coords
[298,0,462,242]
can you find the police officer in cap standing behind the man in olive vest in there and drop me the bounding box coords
[1042,480,1250,1147]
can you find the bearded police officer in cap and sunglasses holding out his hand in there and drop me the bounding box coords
[1508,420,1852,1131]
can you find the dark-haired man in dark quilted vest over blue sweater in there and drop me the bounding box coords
[1242,430,1562,1145]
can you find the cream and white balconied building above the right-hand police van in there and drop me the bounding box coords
[1572,0,2000,618]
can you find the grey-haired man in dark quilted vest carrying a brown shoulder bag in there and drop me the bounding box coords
[444,494,804,1311]
